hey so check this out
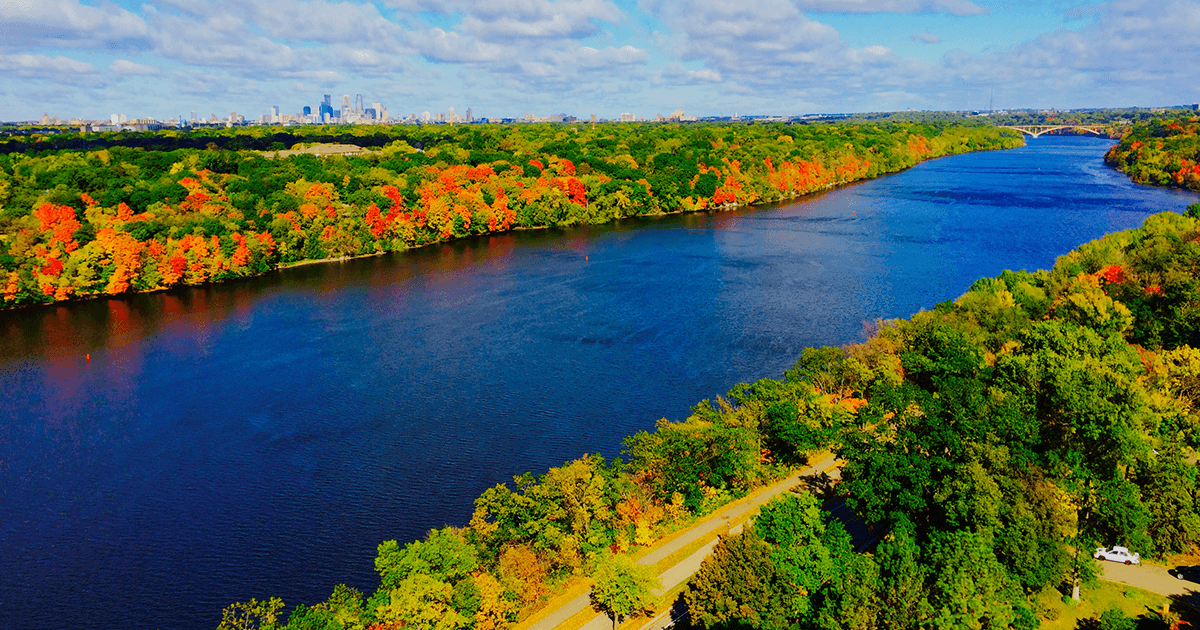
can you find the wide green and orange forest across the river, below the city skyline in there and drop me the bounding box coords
[0,122,1022,308]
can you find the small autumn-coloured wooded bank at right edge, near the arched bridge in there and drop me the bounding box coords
[1104,114,1200,191]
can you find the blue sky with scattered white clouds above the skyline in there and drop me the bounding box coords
[0,0,1200,120]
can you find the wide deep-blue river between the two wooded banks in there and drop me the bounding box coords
[0,137,1200,630]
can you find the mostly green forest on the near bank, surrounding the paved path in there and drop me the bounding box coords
[220,204,1200,630]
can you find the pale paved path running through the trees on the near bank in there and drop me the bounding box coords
[528,456,836,630]
